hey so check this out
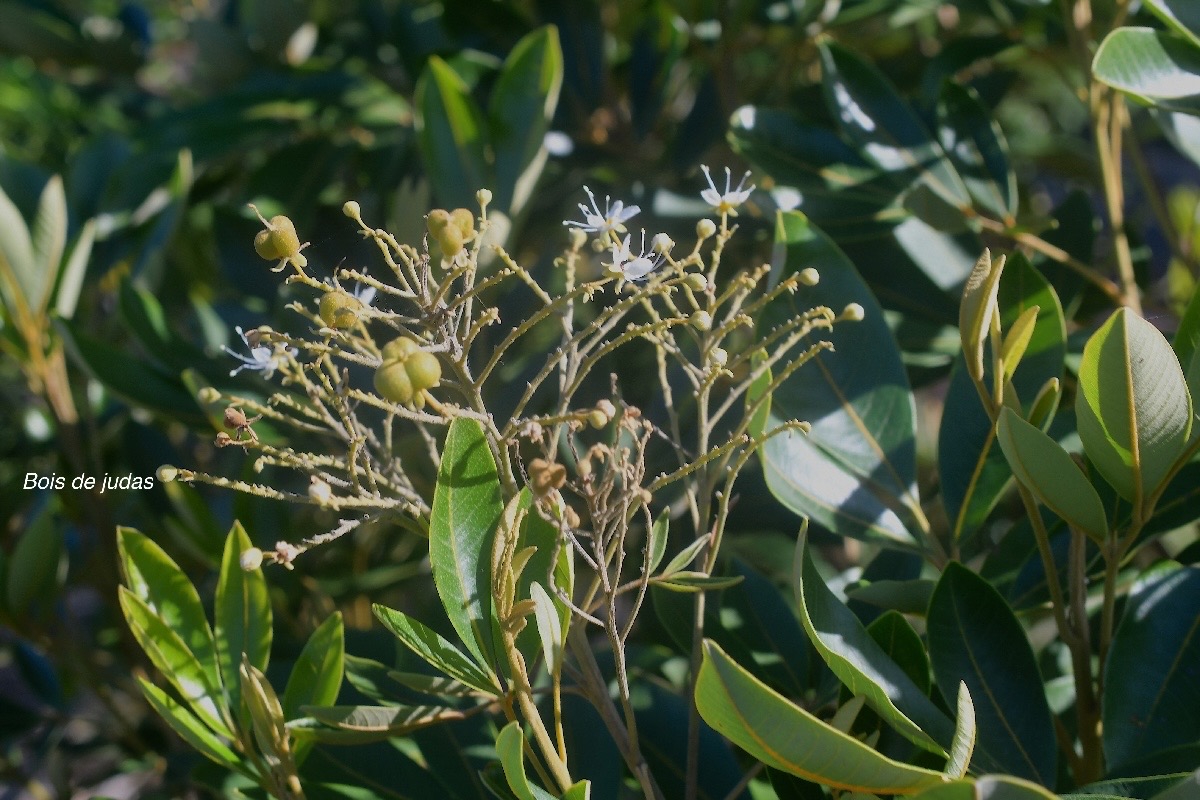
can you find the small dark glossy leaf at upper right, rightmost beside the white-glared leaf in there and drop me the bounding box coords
[937,80,1016,219]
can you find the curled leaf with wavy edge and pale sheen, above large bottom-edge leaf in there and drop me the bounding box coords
[792,530,954,756]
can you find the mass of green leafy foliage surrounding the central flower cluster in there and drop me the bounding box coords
[7,0,1200,799]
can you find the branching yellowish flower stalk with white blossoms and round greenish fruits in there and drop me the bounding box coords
[160,168,863,799]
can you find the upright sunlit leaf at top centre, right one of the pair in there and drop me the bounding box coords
[487,25,563,216]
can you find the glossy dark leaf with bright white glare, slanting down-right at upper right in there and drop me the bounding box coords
[820,42,970,206]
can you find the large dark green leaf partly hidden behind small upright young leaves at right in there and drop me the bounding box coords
[937,253,1067,540]
